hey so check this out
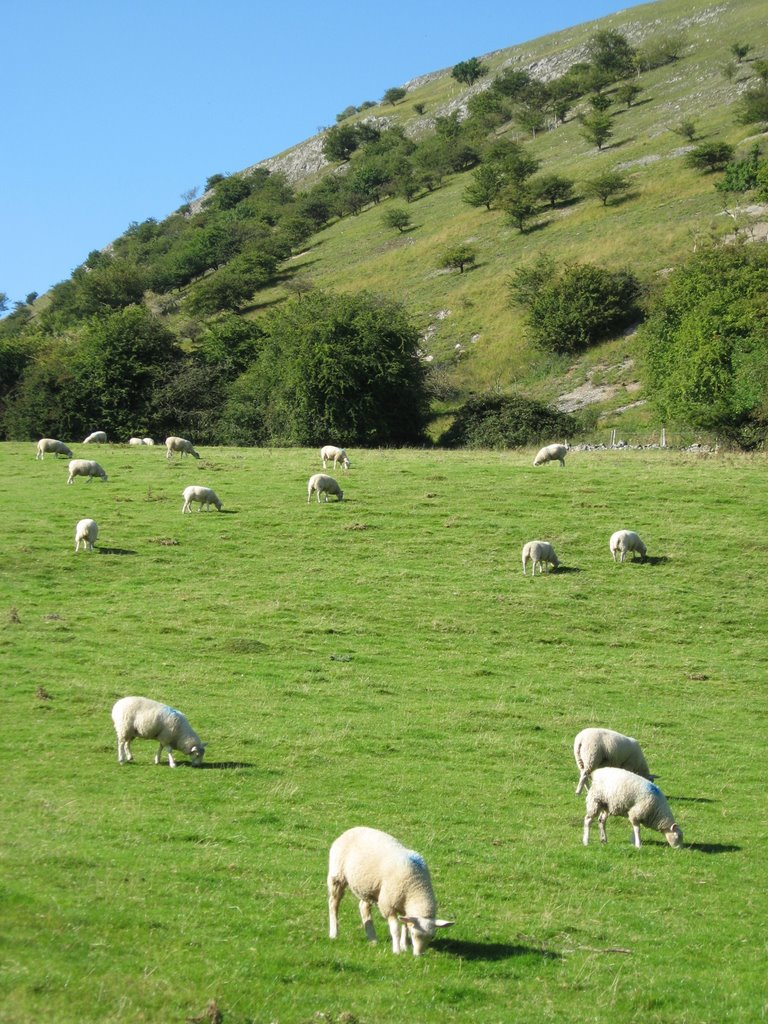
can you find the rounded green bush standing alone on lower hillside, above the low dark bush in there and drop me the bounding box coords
[510,257,640,352]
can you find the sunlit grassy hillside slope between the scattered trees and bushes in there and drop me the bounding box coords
[244,0,768,426]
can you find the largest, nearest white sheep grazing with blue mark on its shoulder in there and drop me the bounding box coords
[328,826,454,956]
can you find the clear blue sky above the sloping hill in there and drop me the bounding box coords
[0,0,643,300]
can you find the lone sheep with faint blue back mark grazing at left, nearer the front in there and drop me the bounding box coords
[112,697,207,768]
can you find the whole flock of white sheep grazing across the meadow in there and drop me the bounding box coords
[36,431,683,956]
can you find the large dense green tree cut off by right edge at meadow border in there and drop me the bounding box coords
[643,246,768,447]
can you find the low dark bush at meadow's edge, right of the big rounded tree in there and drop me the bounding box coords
[437,394,577,449]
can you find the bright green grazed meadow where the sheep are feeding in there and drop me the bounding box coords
[0,443,768,1024]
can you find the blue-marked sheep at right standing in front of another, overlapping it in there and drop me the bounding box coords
[583,768,683,847]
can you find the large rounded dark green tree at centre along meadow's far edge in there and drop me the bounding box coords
[227,291,428,446]
